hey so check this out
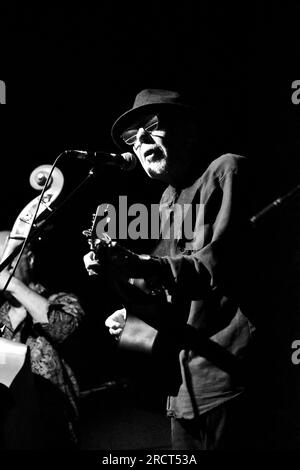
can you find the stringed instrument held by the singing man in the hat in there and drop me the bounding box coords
[83,206,180,386]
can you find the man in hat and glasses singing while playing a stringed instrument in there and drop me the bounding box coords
[85,89,262,450]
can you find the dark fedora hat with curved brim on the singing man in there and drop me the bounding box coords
[111,88,196,149]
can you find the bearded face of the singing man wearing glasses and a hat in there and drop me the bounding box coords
[122,113,196,182]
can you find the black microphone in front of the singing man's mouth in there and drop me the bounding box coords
[66,150,137,171]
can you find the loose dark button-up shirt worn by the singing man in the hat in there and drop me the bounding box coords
[155,154,255,419]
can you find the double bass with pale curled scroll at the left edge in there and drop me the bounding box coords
[0,165,64,450]
